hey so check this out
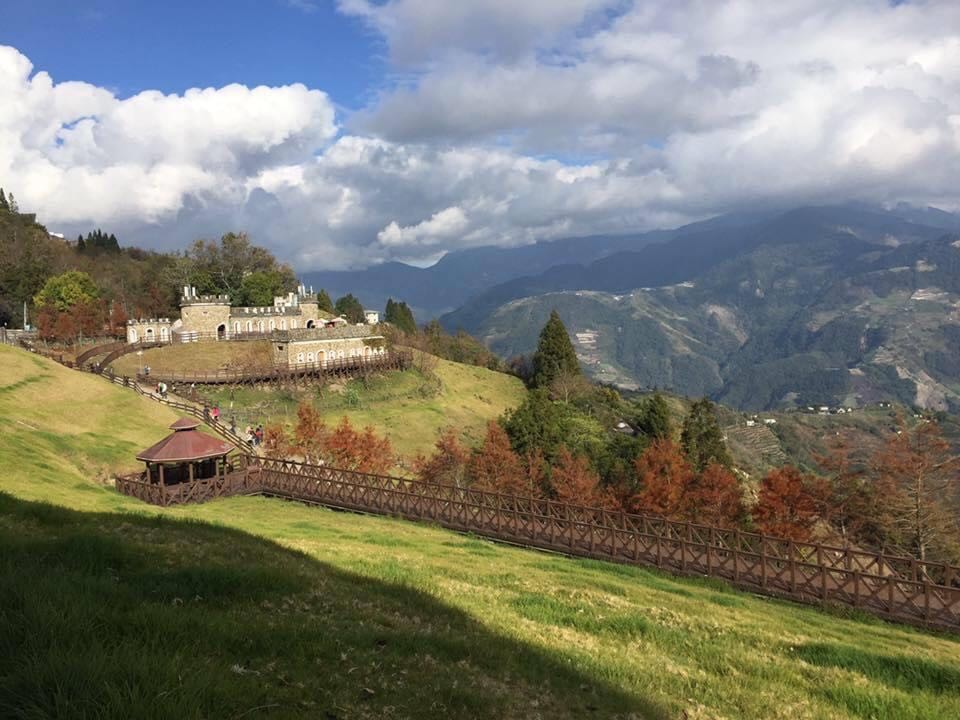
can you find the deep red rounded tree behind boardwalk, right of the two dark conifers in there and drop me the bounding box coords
[753,466,818,541]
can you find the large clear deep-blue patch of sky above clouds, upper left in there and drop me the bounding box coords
[0,0,385,108]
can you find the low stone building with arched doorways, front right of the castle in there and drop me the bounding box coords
[272,325,387,367]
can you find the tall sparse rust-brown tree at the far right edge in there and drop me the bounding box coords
[876,419,960,560]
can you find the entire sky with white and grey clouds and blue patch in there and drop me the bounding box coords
[0,0,960,271]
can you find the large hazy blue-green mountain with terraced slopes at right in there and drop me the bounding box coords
[444,207,960,410]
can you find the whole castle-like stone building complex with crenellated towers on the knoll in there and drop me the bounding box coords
[127,285,386,365]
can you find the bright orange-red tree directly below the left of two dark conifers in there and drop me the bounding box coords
[629,439,694,520]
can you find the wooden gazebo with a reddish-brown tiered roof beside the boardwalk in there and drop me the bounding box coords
[137,418,234,486]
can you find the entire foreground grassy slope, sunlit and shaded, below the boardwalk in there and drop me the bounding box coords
[0,348,960,718]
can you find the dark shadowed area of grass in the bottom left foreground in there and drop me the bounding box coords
[0,493,667,720]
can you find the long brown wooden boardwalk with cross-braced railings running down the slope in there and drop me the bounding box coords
[117,457,960,632]
